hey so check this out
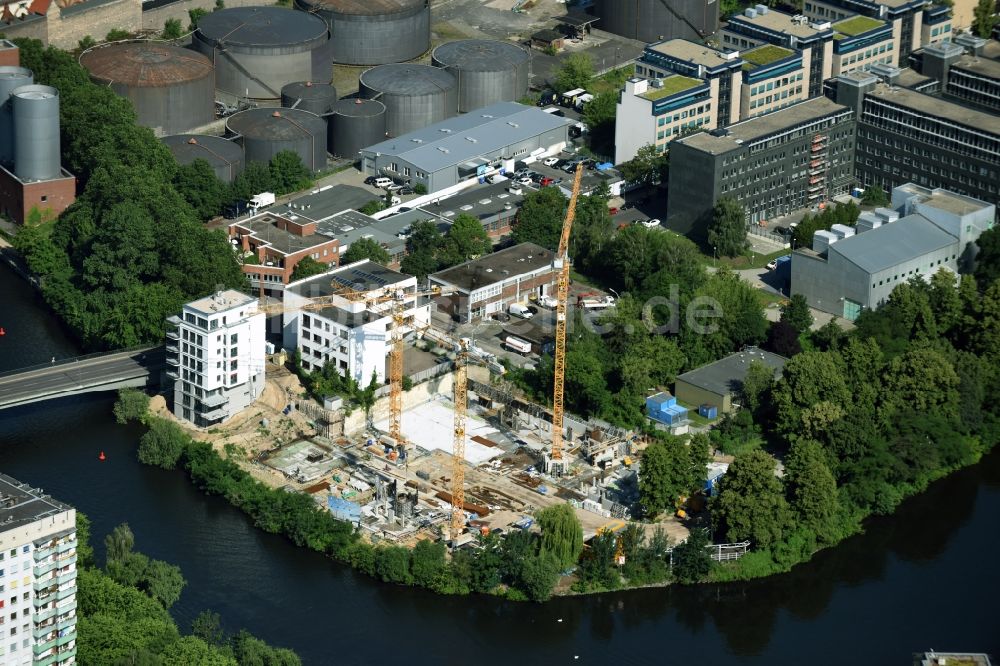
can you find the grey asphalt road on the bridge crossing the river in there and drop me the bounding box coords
[0,348,164,409]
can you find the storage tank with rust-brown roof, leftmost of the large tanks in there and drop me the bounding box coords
[80,42,215,135]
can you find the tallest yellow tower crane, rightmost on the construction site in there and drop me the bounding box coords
[548,164,583,475]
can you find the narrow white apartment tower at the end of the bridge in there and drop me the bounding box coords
[167,289,265,428]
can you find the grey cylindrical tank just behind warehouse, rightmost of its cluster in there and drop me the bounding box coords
[431,39,531,113]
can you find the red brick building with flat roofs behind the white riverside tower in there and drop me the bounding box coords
[229,213,340,295]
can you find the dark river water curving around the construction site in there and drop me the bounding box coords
[0,267,1000,665]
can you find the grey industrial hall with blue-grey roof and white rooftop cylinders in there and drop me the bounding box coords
[791,183,996,320]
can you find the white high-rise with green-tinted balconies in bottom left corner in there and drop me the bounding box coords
[0,474,76,666]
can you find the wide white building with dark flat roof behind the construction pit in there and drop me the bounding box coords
[283,259,431,386]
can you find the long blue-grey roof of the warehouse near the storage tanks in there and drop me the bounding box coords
[361,102,572,172]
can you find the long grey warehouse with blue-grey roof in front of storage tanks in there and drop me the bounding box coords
[361,102,572,192]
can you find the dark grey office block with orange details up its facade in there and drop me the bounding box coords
[667,97,854,237]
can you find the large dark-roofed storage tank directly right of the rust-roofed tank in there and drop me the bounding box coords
[193,7,331,99]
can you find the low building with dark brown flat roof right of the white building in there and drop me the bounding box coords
[429,243,557,322]
